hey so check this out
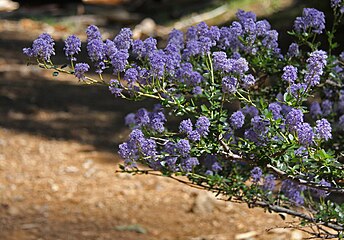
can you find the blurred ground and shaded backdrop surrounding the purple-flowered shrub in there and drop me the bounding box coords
[0,0,343,240]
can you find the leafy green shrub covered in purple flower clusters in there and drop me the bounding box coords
[24,0,344,238]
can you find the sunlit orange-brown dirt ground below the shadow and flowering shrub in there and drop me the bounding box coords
[0,125,306,240]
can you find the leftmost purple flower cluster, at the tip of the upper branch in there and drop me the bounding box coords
[23,33,55,61]
